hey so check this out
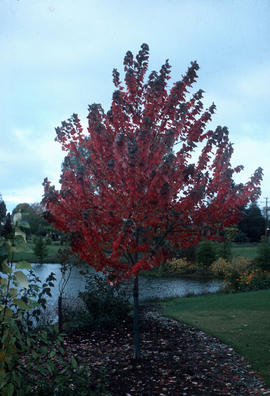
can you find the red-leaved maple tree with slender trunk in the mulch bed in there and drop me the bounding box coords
[43,44,262,357]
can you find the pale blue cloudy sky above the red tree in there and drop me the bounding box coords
[0,0,270,211]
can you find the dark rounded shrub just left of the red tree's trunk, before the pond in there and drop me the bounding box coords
[64,274,131,331]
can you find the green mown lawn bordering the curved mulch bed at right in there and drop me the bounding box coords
[164,290,270,386]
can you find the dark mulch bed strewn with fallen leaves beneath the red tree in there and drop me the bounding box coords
[65,306,270,396]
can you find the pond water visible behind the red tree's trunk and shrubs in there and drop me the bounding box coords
[32,264,224,303]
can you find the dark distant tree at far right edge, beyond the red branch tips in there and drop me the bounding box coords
[238,203,265,242]
